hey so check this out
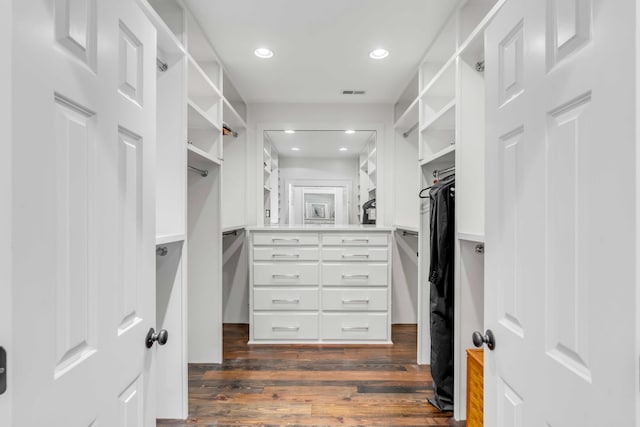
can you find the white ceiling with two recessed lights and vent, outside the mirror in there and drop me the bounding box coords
[186,0,459,103]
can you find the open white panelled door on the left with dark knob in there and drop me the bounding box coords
[10,0,156,427]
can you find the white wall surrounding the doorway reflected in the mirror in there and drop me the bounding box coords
[279,156,359,224]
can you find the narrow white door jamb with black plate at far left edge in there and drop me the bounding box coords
[0,1,13,426]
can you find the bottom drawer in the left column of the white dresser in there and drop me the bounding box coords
[253,313,318,341]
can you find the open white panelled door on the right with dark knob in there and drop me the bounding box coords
[484,0,638,427]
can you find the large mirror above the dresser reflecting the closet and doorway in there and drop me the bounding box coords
[264,130,377,225]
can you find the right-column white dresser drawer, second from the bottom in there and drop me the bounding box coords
[322,288,388,311]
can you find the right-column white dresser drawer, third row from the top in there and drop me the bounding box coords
[322,262,387,286]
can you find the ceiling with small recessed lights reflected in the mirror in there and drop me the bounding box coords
[265,130,375,159]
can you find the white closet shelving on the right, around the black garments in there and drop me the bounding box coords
[394,0,504,419]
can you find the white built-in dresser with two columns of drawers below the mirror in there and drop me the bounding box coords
[249,226,392,344]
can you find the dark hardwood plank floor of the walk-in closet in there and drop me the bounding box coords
[157,325,464,427]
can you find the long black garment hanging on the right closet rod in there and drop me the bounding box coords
[429,175,455,411]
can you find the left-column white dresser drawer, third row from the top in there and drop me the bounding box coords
[253,262,318,286]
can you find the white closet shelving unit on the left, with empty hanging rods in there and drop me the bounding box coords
[144,0,251,412]
